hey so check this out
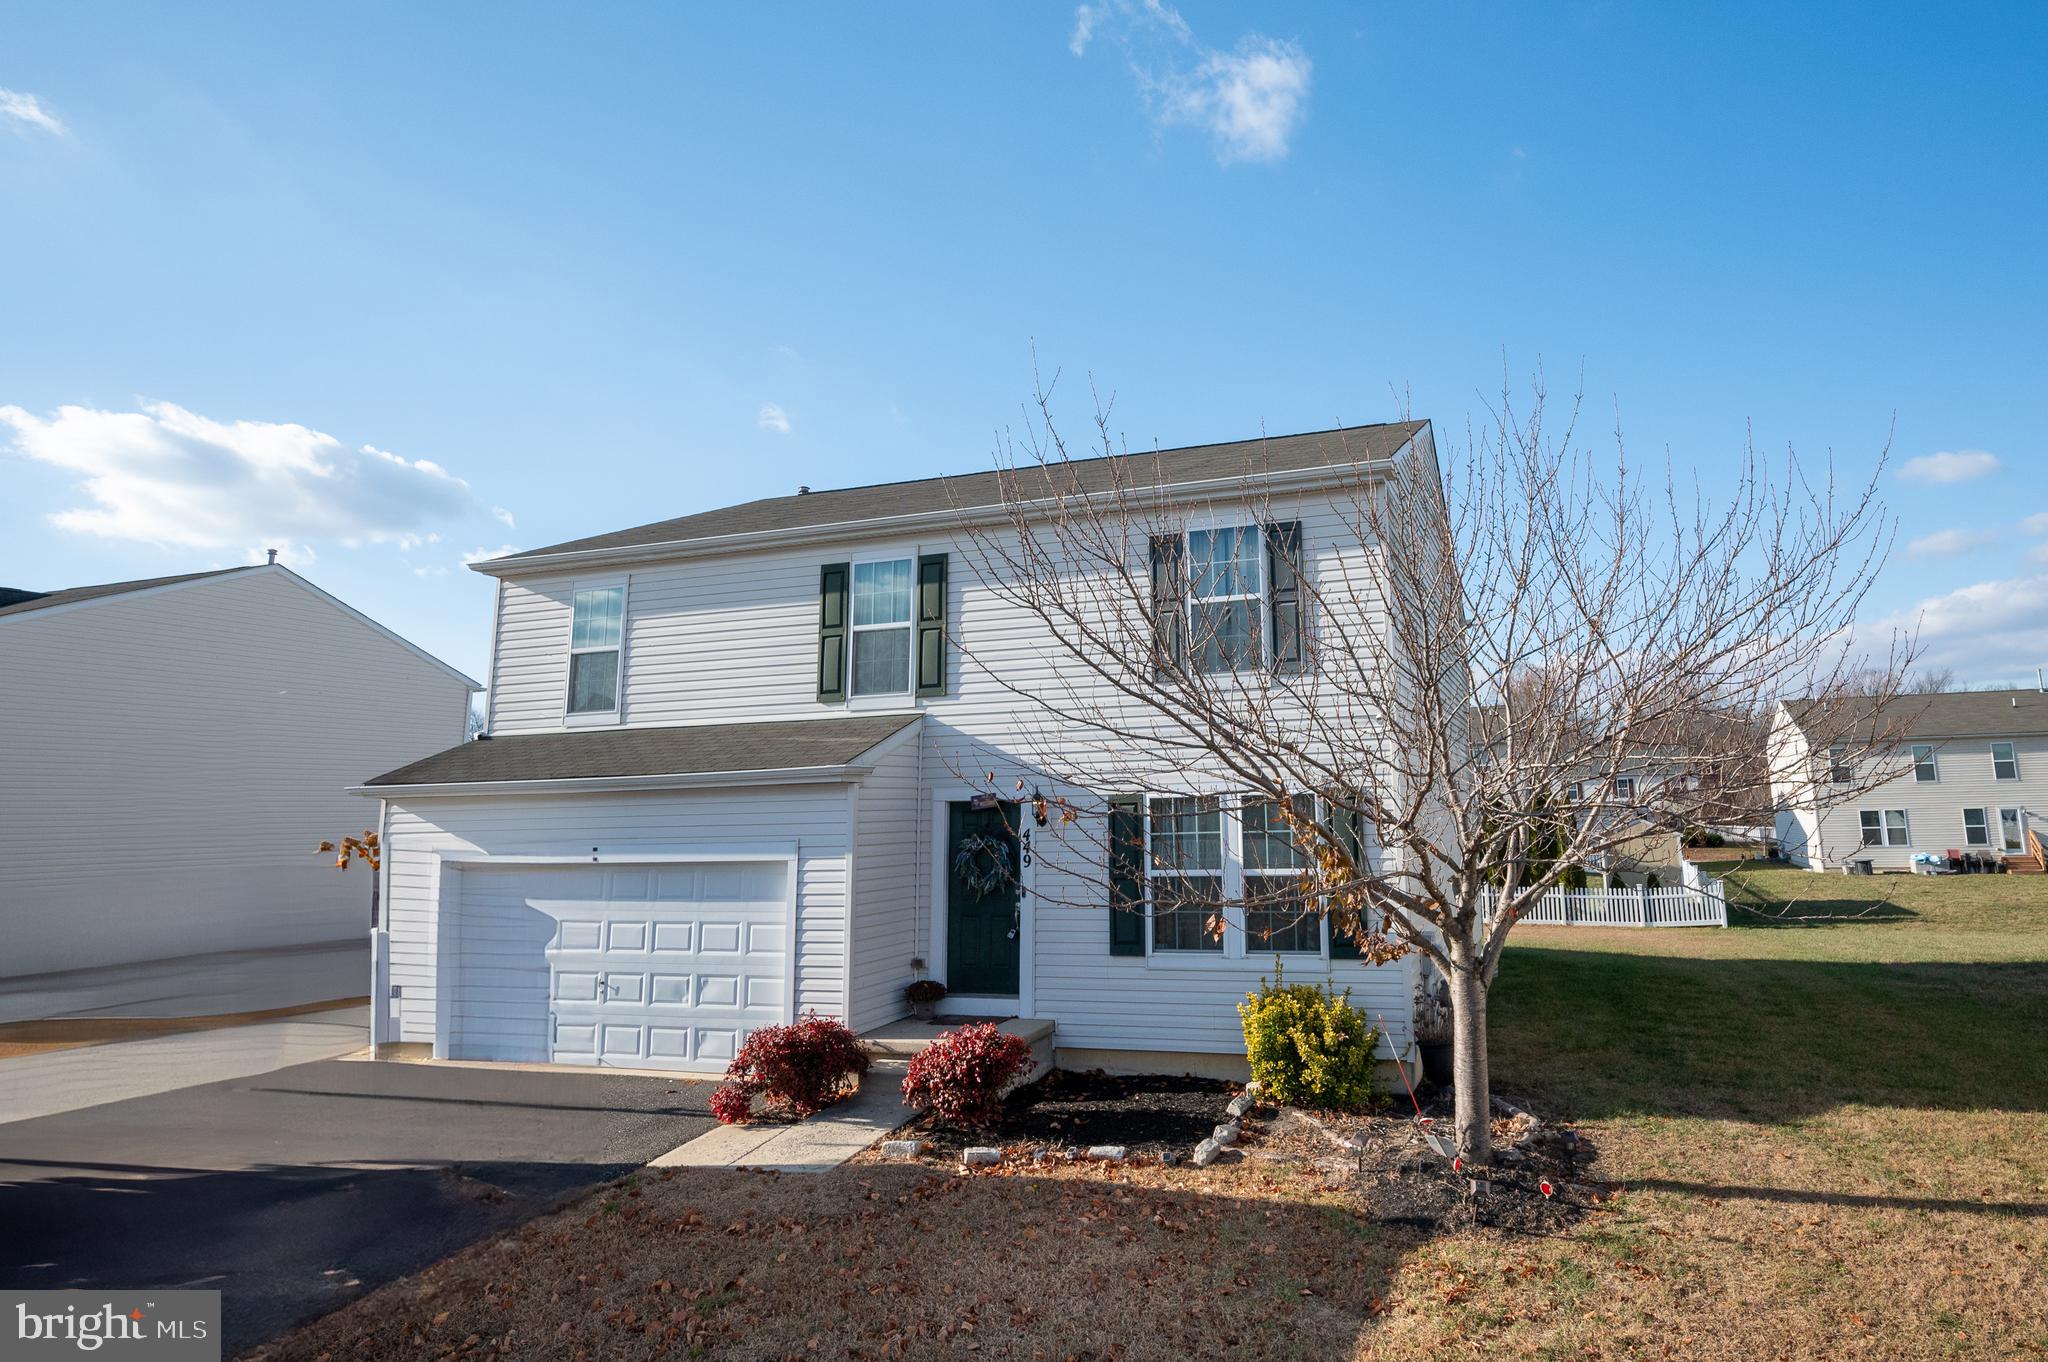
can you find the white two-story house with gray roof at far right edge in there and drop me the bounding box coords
[1772,690,2048,870]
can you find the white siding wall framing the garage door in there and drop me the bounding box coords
[387,784,850,1047]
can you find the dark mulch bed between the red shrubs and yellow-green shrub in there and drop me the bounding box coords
[907,1069,1243,1159]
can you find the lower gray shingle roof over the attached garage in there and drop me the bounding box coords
[365,715,918,786]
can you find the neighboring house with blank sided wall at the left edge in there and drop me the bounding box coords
[0,565,477,1016]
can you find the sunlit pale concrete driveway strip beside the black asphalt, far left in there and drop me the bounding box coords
[0,1008,371,1124]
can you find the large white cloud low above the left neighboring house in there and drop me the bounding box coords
[0,401,505,561]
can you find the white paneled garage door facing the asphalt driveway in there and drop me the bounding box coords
[457,862,791,1073]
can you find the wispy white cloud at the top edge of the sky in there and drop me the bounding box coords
[1067,0,1315,164]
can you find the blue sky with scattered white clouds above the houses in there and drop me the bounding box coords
[0,0,2048,682]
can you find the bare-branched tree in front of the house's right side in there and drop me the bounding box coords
[956,368,1911,1163]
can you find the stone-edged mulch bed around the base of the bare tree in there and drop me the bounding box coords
[1262,1092,1610,1235]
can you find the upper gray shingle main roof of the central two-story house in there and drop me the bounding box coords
[492,420,1427,563]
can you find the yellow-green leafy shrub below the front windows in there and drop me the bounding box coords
[1237,961,1380,1110]
